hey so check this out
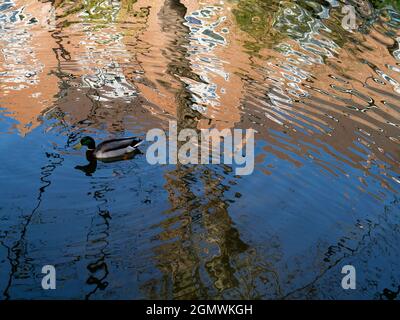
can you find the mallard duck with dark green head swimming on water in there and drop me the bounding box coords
[74,137,143,161]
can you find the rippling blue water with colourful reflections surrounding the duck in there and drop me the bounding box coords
[0,0,400,299]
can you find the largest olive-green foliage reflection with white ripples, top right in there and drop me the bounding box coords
[232,0,345,53]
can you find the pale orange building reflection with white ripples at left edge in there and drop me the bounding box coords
[0,0,58,135]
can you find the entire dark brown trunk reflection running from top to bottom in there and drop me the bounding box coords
[138,1,260,299]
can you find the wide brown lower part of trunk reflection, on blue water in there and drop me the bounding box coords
[143,167,249,299]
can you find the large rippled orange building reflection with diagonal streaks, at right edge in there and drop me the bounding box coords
[234,1,400,191]
